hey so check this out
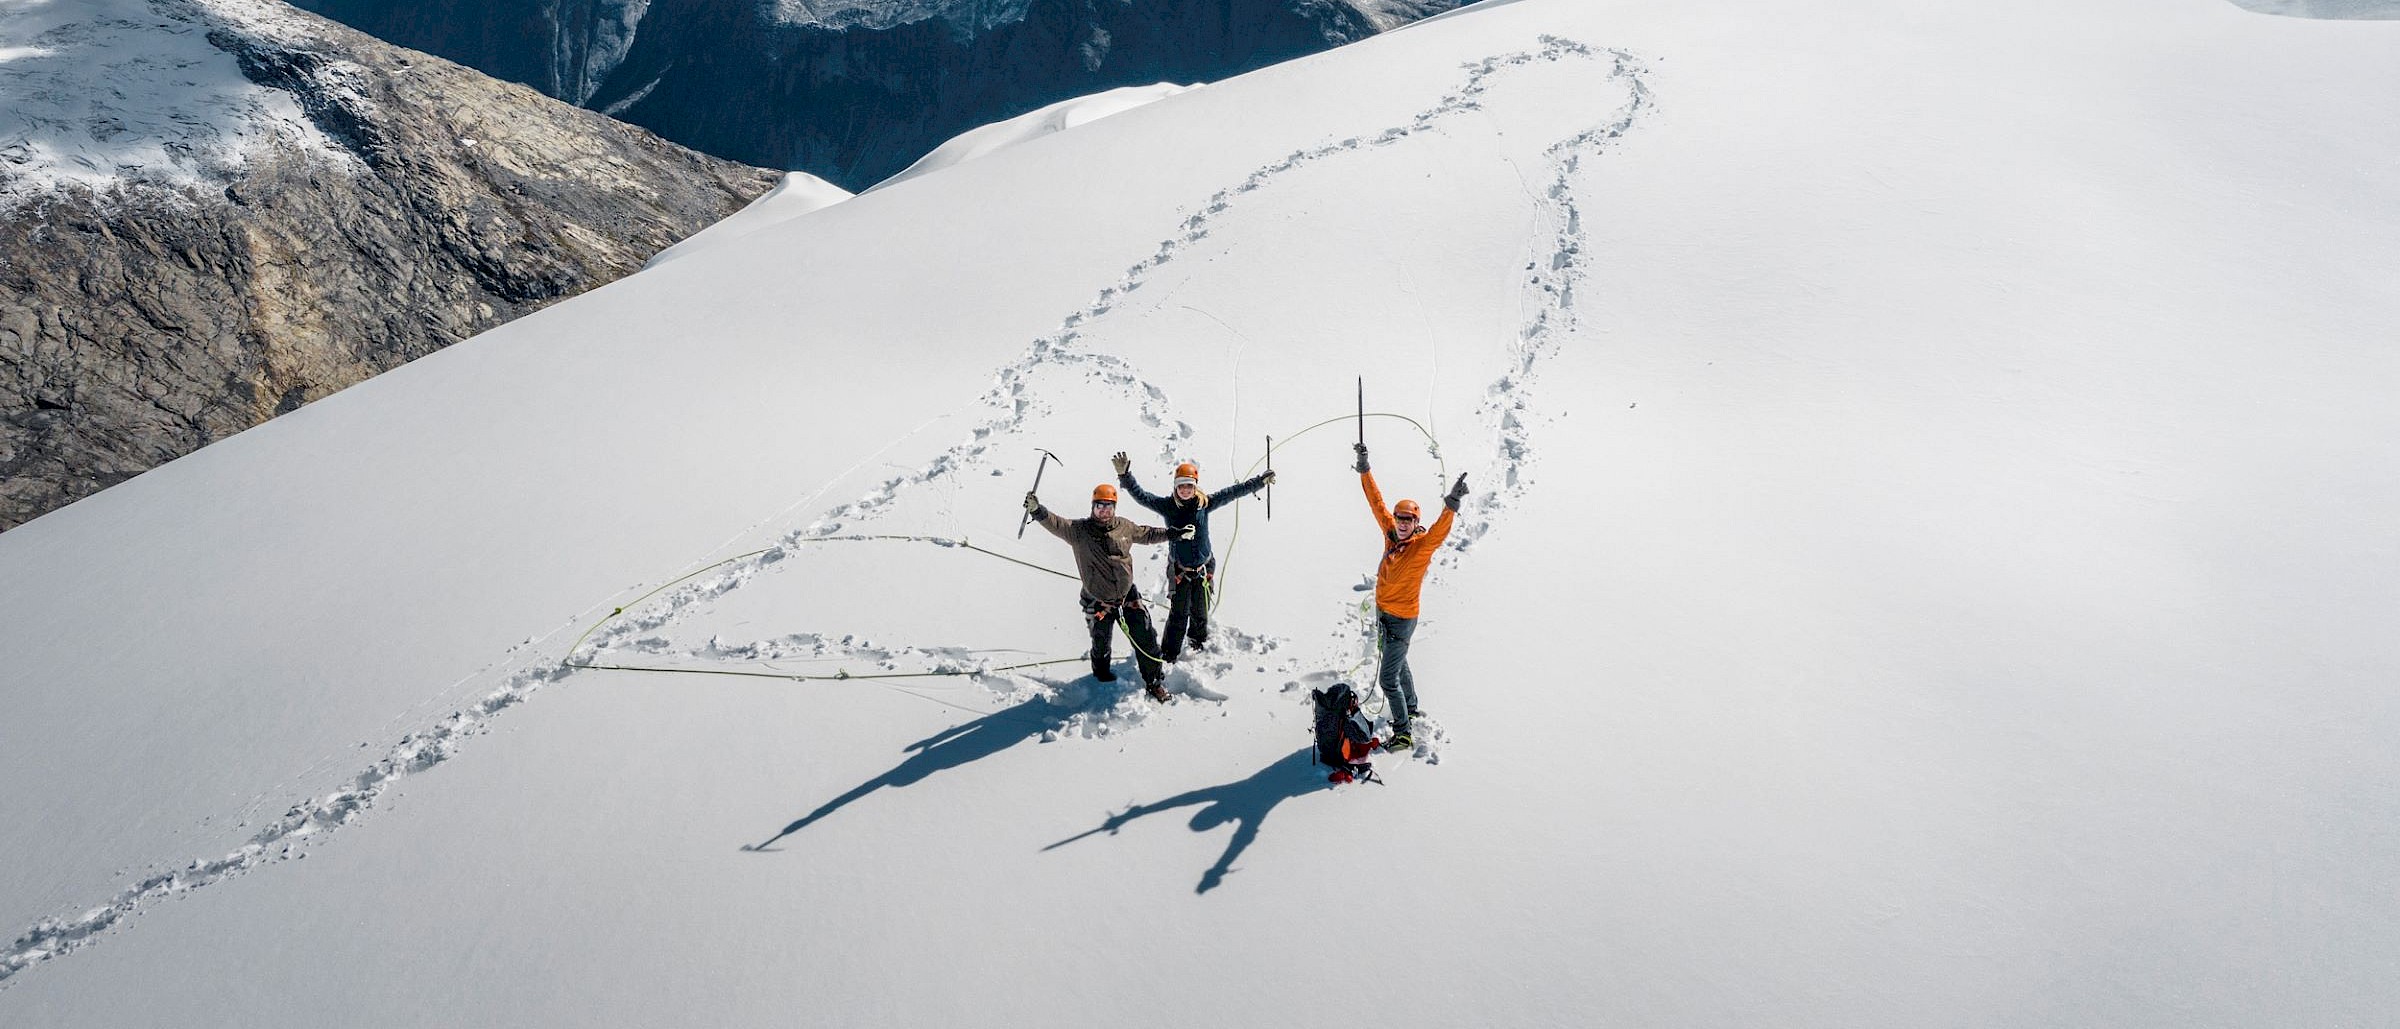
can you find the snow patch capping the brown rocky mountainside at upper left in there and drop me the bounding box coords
[0,0,338,204]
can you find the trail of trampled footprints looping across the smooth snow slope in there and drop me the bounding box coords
[0,36,1651,983]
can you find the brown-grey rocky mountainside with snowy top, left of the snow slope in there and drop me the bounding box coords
[0,0,775,528]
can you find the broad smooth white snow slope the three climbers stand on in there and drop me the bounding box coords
[0,0,2400,1027]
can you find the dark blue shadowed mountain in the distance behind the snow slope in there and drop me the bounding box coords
[300,0,1462,189]
